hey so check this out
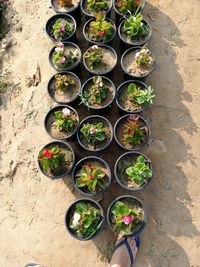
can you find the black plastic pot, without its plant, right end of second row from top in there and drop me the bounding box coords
[118,19,152,47]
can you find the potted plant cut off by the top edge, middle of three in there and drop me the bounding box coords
[81,0,112,18]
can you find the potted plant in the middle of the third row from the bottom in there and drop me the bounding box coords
[77,115,113,151]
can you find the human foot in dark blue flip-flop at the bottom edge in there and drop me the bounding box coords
[110,236,140,267]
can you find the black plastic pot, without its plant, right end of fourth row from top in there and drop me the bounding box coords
[116,80,148,114]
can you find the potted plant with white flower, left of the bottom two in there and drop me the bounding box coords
[65,198,105,241]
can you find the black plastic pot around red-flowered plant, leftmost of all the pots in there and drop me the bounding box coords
[38,141,75,180]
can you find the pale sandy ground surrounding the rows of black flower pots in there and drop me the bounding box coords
[0,0,200,267]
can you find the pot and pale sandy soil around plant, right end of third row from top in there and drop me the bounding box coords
[121,47,155,78]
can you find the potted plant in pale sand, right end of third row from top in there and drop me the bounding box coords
[121,46,155,78]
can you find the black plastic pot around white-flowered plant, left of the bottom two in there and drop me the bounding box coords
[65,198,105,241]
